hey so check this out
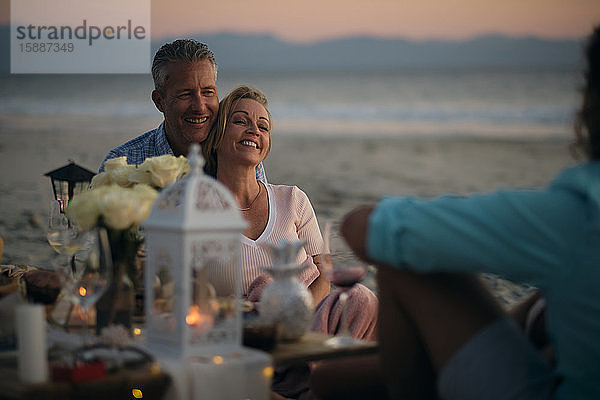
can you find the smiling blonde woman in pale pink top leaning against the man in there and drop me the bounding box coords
[202,86,377,398]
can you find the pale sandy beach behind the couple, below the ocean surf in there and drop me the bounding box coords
[0,116,574,302]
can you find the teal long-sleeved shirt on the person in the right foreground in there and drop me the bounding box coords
[367,162,600,399]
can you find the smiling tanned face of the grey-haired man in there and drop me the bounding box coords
[152,60,219,155]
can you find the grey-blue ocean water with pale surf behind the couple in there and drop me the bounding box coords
[0,69,580,138]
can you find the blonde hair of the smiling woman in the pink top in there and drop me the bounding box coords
[202,85,273,177]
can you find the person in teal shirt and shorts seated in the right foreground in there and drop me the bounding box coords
[341,26,600,400]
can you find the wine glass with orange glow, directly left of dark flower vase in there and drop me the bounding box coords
[65,228,113,344]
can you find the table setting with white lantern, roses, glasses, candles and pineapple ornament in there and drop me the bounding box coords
[0,146,376,400]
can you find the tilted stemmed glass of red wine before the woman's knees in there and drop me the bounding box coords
[321,220,367,348]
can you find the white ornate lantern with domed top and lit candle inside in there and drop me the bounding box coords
[144,145,247,357]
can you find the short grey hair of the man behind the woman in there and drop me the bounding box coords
[152,39,217,95]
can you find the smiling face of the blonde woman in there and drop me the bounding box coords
[217,99,271,166]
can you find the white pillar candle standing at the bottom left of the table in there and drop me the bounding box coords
[16,304,48,383]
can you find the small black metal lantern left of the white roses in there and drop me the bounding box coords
[44,160,96,213]
